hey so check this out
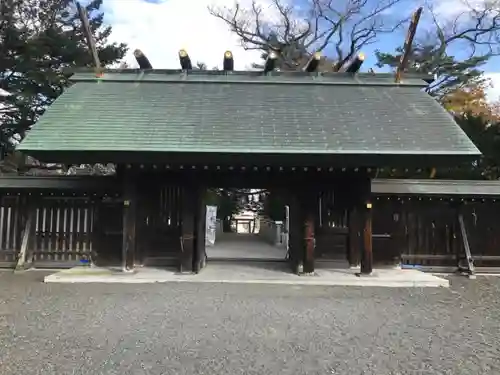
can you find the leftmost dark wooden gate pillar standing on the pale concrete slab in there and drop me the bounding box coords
[122,171,137,271]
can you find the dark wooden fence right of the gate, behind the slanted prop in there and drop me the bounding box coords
[373,197,500,267]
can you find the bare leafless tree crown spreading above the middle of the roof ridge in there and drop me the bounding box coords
[209,0,404,70]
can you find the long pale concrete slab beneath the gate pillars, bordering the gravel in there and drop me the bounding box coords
[44,262,449,287]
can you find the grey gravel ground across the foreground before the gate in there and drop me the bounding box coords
[0,271,500,375]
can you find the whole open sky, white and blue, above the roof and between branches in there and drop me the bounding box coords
[103,0,500,95]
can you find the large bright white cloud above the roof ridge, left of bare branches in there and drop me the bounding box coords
[102,0,272,70]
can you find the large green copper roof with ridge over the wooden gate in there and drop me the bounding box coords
[19,71,479,156]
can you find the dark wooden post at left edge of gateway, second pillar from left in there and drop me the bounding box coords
[179,185,198,273]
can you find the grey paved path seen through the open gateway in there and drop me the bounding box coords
[206,233,286,260]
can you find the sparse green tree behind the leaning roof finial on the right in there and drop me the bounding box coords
[376,0,500,101]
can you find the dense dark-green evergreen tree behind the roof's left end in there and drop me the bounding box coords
[0,0,127,151]
